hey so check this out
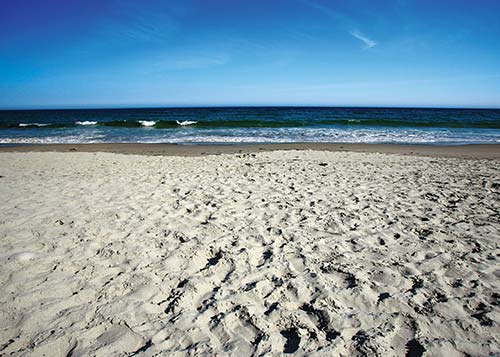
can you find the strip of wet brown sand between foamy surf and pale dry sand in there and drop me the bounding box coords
[0,143,500,160]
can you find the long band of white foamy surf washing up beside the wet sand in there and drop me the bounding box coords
[0,128,500,145]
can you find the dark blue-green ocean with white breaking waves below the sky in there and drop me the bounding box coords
[0,107,500,145]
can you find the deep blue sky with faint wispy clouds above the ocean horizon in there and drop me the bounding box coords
[0,0,500,109]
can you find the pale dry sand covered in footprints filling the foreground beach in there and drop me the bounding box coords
[0,151,500,356]
